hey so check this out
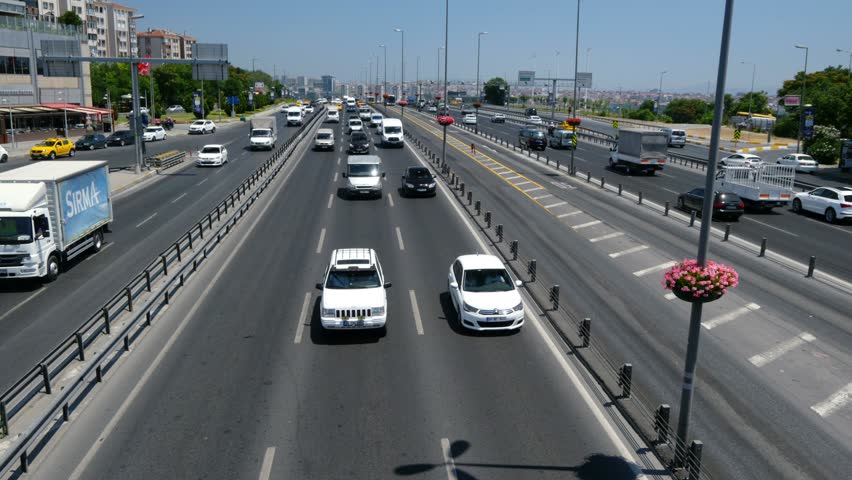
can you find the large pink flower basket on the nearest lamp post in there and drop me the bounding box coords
[663,260,740,303]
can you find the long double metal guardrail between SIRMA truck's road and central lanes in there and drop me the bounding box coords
[0,104,324,473]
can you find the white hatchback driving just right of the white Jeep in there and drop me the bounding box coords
[447,254,524,330]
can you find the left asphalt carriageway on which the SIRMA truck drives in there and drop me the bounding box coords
[0,110,304,390]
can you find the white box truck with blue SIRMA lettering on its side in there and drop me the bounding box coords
[0,161,113,281]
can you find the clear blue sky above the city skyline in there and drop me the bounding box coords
[140,0,852,93]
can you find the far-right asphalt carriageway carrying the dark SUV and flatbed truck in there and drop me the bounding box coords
[442,107,852,281]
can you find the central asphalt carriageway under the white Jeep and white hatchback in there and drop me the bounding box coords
[28,109,667,480]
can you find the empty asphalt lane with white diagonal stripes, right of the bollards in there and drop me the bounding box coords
[382,105,852,479]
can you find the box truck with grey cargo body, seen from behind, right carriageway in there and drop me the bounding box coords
[609,128,668,175]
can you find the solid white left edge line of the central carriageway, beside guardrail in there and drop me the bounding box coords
[68,145,298,480]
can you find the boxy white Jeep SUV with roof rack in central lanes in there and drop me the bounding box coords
[317,248,391,330]
